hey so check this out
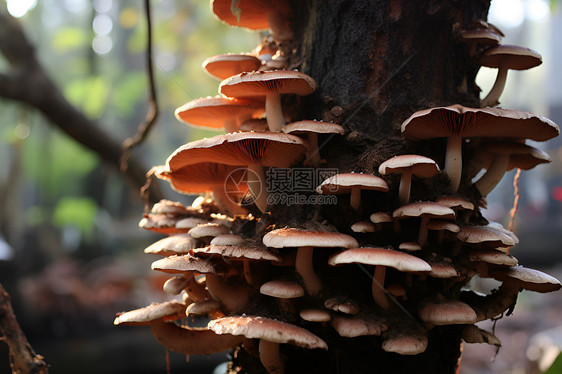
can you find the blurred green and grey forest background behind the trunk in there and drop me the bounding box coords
[0,0,562,373]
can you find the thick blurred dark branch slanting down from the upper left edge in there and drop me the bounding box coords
[0,10,161,201]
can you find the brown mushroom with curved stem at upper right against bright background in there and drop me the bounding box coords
[479,45,542,107]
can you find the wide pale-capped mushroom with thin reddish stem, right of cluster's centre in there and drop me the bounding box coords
[328,247,431,309]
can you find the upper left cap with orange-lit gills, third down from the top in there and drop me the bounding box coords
[219,70,316,98]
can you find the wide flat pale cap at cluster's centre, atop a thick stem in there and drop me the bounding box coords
[263,228,359,248]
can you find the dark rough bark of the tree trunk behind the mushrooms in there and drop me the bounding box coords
[233,0,489,373]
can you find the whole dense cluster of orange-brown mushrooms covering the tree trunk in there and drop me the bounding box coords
[115,5,562,373]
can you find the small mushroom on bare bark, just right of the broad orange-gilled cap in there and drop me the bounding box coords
[283,120,345,167]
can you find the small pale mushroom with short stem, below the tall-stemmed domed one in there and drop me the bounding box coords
[392,201,455,247]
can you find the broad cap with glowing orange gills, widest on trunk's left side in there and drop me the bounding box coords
[165,132,306,172]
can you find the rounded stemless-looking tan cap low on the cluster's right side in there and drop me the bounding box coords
[419,300,477,325]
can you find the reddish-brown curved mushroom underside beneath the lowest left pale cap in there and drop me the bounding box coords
[150,319,243,355]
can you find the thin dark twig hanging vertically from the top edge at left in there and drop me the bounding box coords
[121,0,158,170]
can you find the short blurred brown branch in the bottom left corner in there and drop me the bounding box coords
[0,284,48,374]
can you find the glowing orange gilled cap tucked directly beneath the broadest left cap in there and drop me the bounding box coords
[156,162,248,194]
